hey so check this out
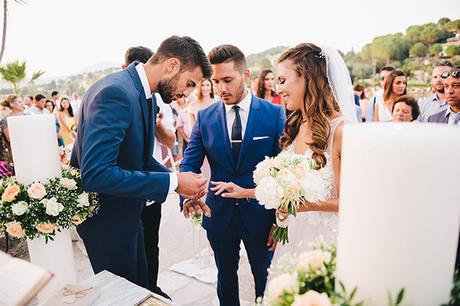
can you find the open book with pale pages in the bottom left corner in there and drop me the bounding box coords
[0,252,53,306]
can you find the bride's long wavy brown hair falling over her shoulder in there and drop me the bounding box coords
[278,43,340,168]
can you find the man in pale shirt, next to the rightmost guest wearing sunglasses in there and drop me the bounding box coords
[418,61,453,122]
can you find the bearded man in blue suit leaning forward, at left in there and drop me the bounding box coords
[71,36,212,288]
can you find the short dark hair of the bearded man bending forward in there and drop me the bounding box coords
[148,36,212,78]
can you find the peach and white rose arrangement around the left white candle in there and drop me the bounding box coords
[0,166,98,242]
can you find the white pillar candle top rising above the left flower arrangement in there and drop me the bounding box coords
[7,115,61,185]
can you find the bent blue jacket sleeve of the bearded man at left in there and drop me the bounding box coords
[80,86,169,203]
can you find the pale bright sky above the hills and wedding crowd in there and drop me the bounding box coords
[2,0,460,77]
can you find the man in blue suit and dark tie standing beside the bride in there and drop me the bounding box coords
[180,45,285,306]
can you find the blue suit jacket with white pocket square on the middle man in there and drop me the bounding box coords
[180,96,286,238]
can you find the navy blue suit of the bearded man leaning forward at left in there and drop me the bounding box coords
[71,63,170,285]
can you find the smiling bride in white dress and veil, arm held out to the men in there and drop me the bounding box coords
[211,43,357,258]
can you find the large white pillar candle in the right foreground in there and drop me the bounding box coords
[337,123,460,306]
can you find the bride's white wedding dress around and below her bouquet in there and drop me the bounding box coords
[272,116,344,263]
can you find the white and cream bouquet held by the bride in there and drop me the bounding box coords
[254,152,333,244]
